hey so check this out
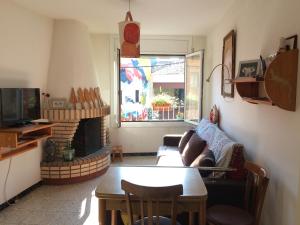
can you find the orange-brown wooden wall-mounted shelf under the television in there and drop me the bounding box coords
[0,123,56,160]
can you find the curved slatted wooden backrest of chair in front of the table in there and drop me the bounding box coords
[121,180,183,225]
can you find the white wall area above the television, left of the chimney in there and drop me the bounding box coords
[0,0,52,89]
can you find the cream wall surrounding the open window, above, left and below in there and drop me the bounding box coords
[92,34,206,152]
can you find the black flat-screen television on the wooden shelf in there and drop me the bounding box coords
[0,88,41,127]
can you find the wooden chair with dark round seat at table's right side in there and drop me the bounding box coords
[207,162,269,225]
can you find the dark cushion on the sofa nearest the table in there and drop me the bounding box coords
[190,146,216,177]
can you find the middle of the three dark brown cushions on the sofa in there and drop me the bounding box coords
[181,133,206,166]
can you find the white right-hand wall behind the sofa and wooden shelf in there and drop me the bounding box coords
[206,0,300,225]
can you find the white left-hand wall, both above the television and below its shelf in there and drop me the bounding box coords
[0,0,52,204]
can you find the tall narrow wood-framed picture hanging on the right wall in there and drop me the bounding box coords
[221,30,236,98]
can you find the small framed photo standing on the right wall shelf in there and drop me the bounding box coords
[238,59,262,77]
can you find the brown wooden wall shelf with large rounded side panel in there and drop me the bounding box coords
[232,49,298,111]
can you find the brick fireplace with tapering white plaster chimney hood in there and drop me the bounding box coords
[41,19,110,184]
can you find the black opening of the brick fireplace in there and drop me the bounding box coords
[72,117,104,157]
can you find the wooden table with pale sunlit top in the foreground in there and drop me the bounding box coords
[96,166,207,225]
